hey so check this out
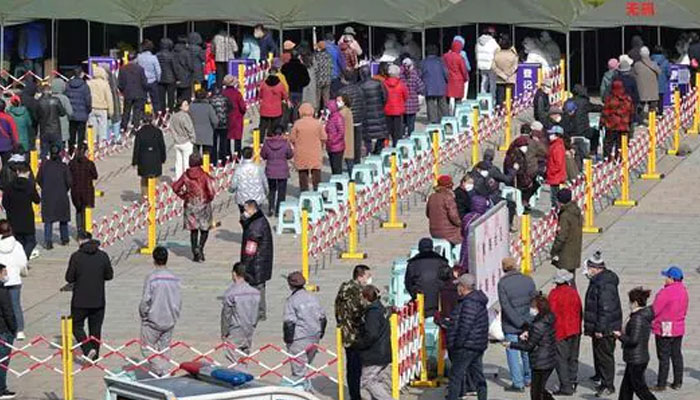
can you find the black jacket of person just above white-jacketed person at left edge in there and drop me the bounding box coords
[2,177,41,235]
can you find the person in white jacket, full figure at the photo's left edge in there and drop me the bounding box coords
[0,219,27,340]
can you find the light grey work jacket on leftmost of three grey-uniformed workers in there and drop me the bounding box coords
[139,269,182,332]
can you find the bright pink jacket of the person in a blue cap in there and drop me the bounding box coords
[651,282,688,337]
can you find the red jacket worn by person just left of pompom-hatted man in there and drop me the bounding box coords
[548,285,582,341]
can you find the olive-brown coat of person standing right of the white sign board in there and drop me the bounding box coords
[550,200,583,271]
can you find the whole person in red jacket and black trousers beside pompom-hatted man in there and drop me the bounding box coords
[548,269,582,396]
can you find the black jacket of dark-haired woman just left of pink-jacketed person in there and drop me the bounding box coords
[620,307,654,364]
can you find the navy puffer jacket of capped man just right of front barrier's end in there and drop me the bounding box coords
[447,290,489,352]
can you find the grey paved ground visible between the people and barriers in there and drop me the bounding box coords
[9,104,700,399]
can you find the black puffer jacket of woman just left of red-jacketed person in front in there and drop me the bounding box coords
[510,312,557,369]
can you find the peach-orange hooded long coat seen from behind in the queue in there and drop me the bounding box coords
[289,103,328,171]
